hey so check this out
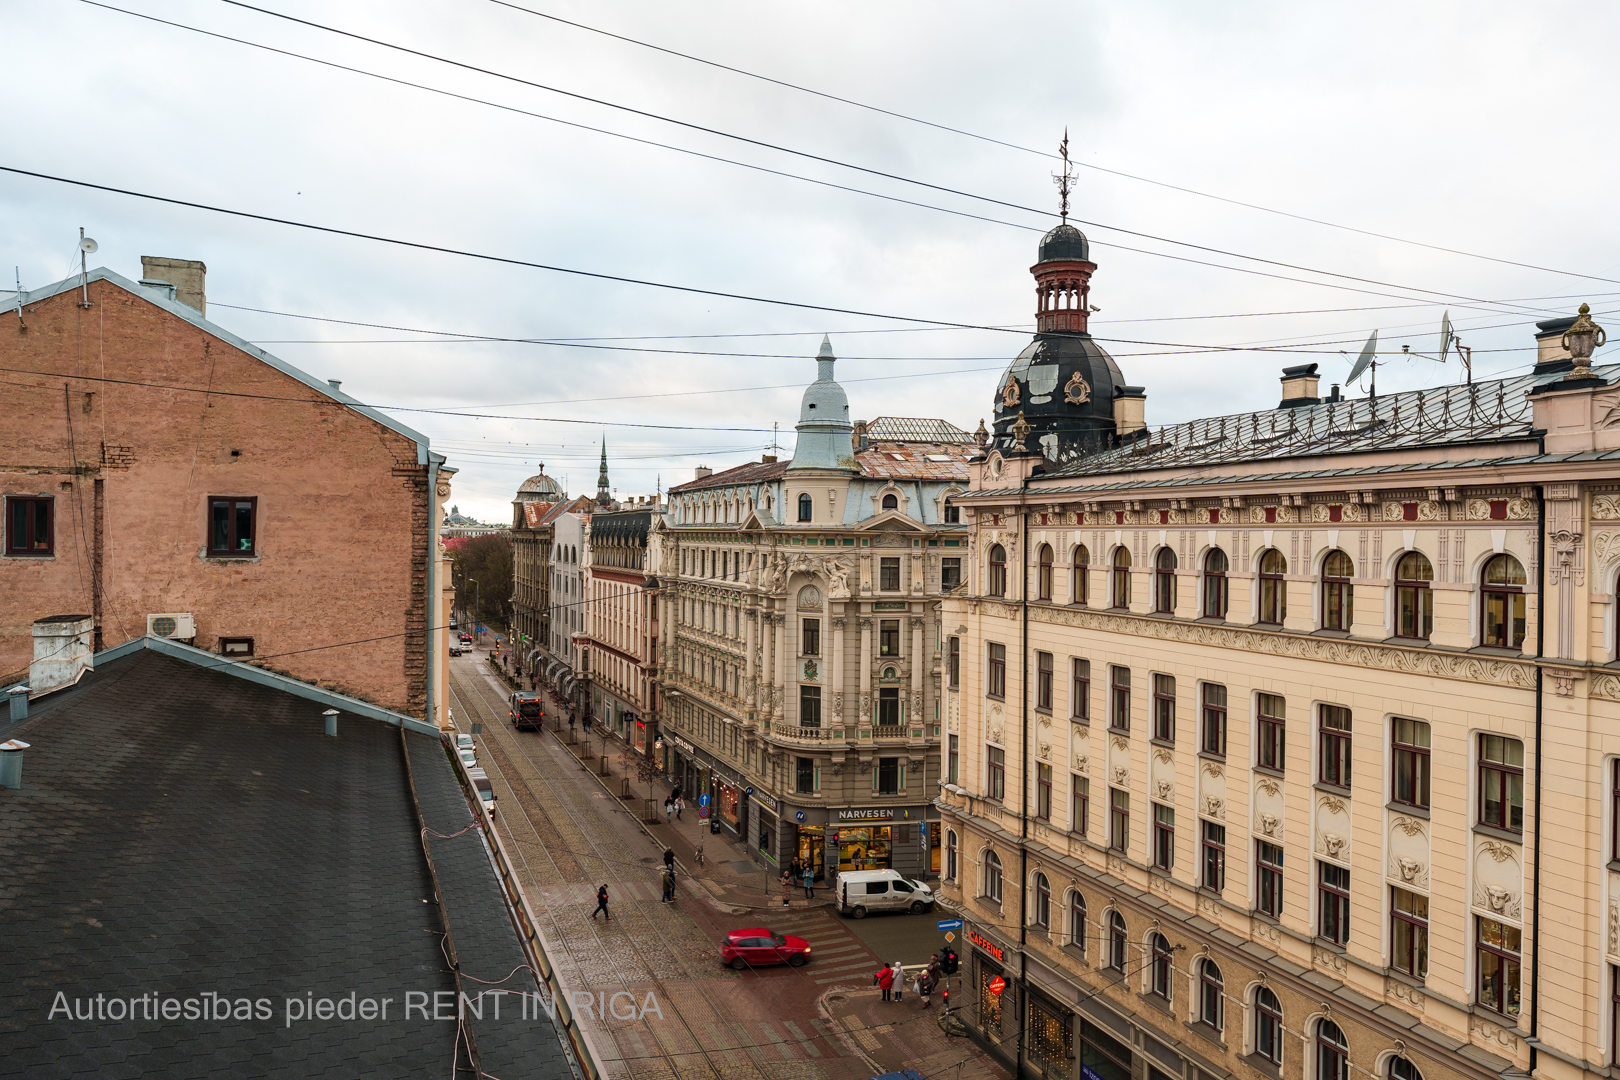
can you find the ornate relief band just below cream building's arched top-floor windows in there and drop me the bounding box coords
[1023,602,1536,690]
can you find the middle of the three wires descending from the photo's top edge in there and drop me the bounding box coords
[170,0,1574,314]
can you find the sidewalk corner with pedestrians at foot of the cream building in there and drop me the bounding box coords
[821,976,1013,1080]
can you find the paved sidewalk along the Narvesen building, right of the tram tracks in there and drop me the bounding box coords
[524,688,833,915]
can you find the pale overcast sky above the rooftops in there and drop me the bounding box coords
[0,0,1620,520]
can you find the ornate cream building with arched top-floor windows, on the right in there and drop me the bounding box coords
[940,223,1620,1080]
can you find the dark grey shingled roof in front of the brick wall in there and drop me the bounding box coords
[0,649,572,1080]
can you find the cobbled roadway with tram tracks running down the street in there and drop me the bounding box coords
[450,669,822,1080]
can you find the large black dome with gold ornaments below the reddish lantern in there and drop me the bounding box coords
[995,333,1124,460]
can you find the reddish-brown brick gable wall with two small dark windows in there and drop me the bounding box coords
[0,270,447,714]
